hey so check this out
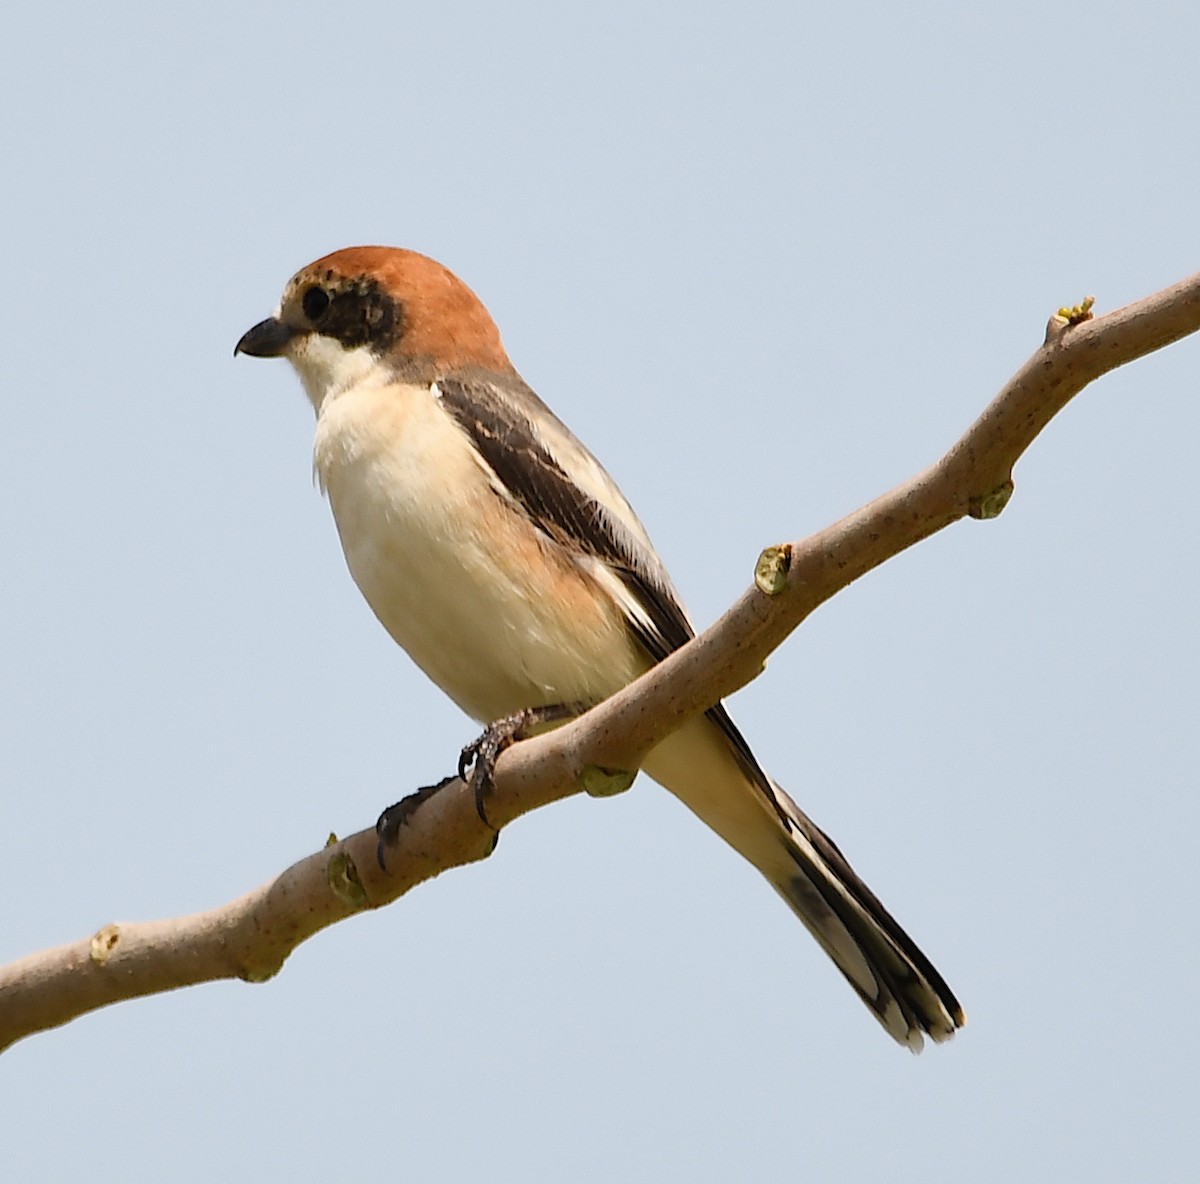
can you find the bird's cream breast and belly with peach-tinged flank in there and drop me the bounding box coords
[313,384,647,720]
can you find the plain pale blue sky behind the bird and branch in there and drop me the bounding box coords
[0,2,1200,1184]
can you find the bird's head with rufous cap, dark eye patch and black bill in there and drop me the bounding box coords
[234,247,512,411]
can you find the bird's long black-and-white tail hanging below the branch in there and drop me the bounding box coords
[643,708,966,1052]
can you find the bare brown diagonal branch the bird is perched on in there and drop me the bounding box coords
[0,275,1200,1050]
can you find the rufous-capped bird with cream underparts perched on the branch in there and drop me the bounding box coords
[234,246,966,1052]
